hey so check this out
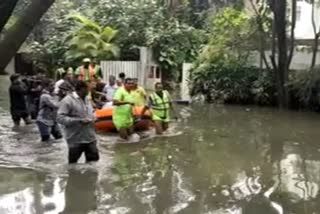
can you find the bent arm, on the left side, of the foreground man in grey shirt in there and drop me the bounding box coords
[57,98,83,126]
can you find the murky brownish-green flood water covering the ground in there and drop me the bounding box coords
[0,78,320,214]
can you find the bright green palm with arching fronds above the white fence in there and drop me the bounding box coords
[65,14,120,61]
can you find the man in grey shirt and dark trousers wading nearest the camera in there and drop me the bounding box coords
[58,80,99,164]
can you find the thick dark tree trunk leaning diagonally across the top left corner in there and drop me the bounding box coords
[0,0,55,71]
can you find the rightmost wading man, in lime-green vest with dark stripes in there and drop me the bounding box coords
[141,82,177,135]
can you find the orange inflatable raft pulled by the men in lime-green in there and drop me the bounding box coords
[95,107,152,132]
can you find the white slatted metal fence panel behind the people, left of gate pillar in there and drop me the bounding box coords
[101,61,143,84]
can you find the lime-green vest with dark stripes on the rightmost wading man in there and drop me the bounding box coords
[150,90,171,119]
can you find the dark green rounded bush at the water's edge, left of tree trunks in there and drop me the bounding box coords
[190,58,274,104]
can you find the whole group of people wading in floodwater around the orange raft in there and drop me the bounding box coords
[9,58,178,163]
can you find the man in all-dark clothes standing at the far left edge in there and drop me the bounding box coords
[9,74,31,126]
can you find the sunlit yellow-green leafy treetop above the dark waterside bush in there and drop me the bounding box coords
[200,7,253,62]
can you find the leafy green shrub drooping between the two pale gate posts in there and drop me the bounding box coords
[147,19,205,80]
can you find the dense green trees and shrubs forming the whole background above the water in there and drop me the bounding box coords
[0,0,320,109]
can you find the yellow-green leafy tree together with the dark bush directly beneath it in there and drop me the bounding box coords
[191,7,274,104]
